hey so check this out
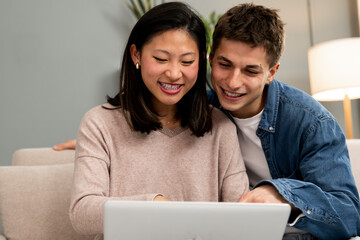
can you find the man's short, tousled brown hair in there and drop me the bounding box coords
[212,3,285,68]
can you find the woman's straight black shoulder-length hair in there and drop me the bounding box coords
[108,2,212,137]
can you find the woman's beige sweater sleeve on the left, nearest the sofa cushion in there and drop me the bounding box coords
[69,108,158,235]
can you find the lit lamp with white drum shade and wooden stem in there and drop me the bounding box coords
[308,38,360,139]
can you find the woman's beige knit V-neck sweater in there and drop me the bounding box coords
[70,104,249,238]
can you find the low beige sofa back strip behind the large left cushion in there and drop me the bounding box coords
[12,148,75,165]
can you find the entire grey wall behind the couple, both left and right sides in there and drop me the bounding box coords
[0,0,360,165]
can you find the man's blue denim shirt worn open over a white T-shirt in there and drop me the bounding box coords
[208,80,360,239]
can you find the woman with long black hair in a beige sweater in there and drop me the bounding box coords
[70,2,248,238]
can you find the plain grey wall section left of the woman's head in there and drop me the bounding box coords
[0,0,135,165]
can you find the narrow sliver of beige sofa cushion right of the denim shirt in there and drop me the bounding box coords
[346,139,360,190]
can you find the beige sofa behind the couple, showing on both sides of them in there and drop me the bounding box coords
[0,139,360,240]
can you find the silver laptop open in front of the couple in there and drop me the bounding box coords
[103,200,290,240]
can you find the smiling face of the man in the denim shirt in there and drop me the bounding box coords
[210,38,279,118]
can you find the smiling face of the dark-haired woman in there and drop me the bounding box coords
[130,29,199,109]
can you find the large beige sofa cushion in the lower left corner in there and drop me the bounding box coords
[0,164,89,240]
